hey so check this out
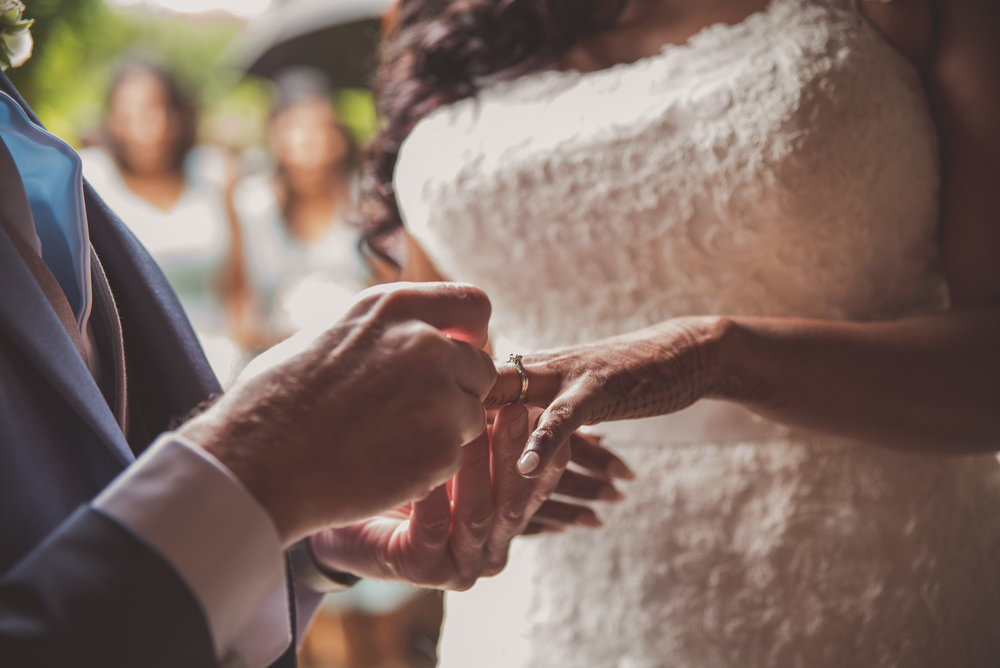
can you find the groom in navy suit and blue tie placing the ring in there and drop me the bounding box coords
[0,74,527,667]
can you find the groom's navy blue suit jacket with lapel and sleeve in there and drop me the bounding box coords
[0,74,295,667]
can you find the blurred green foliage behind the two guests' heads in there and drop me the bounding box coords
[7,0,375,148]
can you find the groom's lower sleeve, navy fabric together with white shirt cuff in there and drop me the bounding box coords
[0,433,298,668]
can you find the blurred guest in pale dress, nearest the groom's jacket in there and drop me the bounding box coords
[81,60,243,383]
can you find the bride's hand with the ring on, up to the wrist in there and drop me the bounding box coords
[486,317,723,477]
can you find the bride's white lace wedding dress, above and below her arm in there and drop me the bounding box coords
[395,0,1000,668]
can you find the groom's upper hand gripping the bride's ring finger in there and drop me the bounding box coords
[179,283,496,545]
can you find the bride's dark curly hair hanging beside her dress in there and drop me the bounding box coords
[359,0,627,268]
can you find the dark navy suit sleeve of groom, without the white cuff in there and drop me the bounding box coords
[0,507,218,668]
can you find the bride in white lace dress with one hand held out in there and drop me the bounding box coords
[366,0,1000,668]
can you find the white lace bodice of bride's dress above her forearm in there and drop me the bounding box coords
[395,0,943,354]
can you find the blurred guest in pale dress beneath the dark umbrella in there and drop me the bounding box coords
[230,67,364,350]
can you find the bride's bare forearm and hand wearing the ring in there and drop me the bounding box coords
[486,305,1000,476]
